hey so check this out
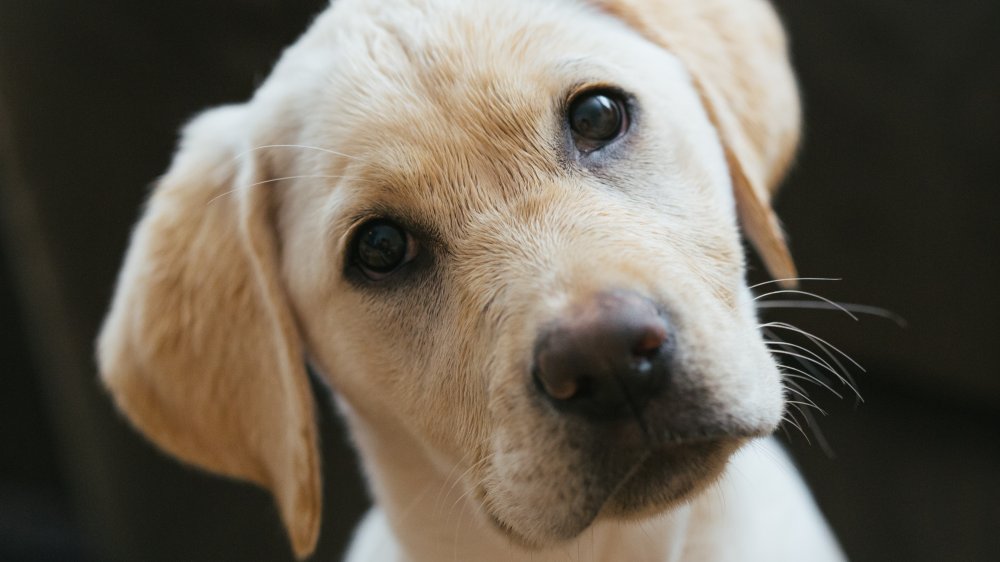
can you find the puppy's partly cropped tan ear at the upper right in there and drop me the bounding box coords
[590,0,801,286]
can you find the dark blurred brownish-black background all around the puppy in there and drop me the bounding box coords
[0,0,1000,562]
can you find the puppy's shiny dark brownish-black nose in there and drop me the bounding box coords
[534,291,674,420]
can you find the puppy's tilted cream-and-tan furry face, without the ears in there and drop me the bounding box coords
[278,0,781,544]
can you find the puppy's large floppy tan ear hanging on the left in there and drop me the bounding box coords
[98,106,321,557]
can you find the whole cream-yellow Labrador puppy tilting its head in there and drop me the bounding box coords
[98,0,842,562]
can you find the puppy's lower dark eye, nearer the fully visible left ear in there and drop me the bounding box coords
[352,219,417,281]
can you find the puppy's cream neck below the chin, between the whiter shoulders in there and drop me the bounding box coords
[349,404,691,562]
